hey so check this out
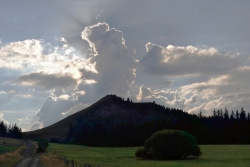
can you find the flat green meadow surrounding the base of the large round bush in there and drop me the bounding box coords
[48,143,250,167]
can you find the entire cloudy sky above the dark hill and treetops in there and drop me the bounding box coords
[0,0,250,131]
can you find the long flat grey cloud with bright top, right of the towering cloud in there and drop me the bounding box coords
[141,43,240,76]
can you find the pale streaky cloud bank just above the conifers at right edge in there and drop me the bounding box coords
[180,66,250,114]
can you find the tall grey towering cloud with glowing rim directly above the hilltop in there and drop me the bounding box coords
[82,23,137,97]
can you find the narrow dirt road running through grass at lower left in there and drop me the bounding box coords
[15,141,41,167]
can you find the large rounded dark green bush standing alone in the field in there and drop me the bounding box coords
[136,129,201,159]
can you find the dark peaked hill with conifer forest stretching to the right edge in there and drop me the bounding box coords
[24,95,250,146]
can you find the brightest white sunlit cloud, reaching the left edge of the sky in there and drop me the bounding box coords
[0,39,91,79]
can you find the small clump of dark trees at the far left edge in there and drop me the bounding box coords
[0,121,22,139]
